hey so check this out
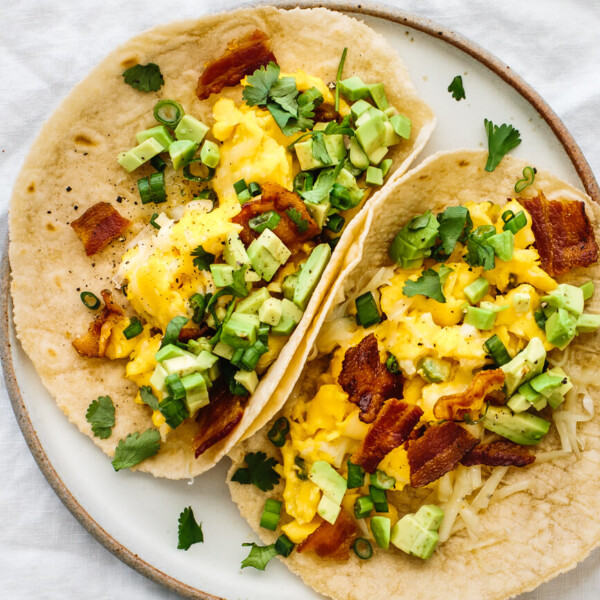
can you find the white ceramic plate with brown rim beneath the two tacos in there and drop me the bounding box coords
[3,2,597,600]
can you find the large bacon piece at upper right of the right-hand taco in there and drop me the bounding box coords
[517,192,598,277]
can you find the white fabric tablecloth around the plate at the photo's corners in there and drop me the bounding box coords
[0,0,600,600]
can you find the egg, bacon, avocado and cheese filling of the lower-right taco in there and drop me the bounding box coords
[232,191,600,560]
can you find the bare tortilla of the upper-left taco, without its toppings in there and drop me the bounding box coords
[10,7,435,479]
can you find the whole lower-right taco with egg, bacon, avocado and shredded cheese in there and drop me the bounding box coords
[228,151,600,600]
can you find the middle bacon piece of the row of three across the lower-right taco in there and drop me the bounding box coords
[407,421,479,487]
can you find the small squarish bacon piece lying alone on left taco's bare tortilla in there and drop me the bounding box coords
[71,202,131,256]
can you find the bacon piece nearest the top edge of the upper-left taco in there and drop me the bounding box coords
[196,29,277,100]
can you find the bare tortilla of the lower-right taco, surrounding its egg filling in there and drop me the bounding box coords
[228,150,600,600]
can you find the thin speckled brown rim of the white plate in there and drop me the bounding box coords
[0,0,600,600]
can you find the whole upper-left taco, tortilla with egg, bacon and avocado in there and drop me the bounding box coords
[10,7,435,478]
